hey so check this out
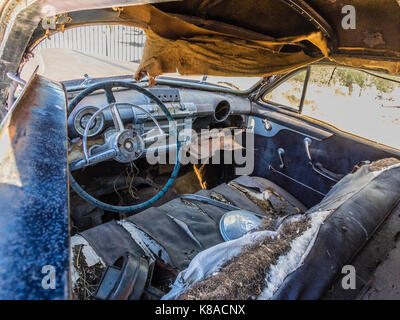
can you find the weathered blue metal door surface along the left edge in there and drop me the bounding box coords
[0,75,69,299]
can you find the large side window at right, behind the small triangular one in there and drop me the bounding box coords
[302,65,400,149]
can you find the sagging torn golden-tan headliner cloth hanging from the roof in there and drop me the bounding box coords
[120,5,329,79]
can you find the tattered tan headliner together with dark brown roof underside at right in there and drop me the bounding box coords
[105,0,400,79]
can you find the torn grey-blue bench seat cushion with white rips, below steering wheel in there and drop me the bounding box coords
[71,176,307,298]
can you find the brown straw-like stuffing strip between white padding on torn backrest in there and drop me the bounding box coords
[178,218,311,300]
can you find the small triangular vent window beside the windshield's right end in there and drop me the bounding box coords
[263,70,307,111]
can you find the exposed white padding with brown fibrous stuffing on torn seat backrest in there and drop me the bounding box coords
[163,211,332,300]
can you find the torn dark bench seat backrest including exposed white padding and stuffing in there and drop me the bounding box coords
[163,158,400,300]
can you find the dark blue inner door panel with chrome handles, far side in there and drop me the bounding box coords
[250,104,400,207]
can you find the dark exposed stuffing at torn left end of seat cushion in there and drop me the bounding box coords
[73,245,104,300]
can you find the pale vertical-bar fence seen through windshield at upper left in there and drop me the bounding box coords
[35,25,146,62]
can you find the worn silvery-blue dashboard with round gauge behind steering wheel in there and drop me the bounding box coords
[68,85,251,167]
